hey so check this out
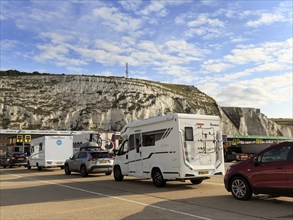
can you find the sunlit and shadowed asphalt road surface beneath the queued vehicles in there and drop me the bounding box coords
[0,168,293,220]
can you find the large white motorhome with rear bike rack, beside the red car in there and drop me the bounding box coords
[114,113,225,187]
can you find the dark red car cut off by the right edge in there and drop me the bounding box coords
[224,142,293,200]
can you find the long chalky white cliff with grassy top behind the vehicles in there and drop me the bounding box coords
[0,71,293,136]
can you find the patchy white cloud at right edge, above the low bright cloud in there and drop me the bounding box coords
[201,38,293,81]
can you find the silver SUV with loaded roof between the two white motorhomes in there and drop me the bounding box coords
[64,148,114,177]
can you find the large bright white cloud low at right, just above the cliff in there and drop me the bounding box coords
[200,73,293,108]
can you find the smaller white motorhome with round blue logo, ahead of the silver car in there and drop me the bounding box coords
[27,136,73,171]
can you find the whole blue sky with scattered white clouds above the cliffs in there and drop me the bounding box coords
[0,0,293,118]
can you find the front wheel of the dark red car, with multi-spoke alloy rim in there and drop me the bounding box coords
[230,176,252,200]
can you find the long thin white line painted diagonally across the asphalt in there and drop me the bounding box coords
[0,171,212,220]
